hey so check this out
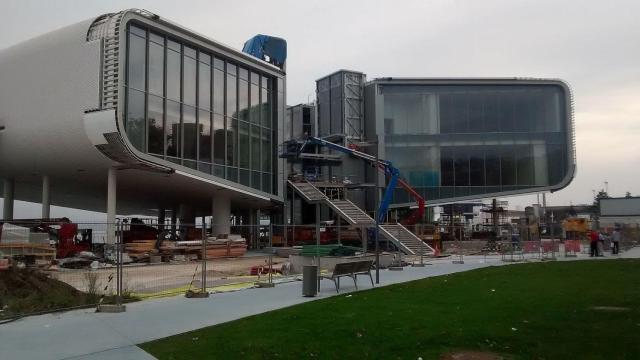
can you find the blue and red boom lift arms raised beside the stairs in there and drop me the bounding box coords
[298,136,425,225]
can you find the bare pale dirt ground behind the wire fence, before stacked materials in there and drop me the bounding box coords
[47,255,287,294]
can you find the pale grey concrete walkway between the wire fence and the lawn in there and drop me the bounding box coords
[0,248,640,360]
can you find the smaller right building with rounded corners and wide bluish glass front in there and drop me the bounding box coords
[365,78,575,206]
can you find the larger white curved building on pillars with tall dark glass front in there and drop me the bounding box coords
[0,9,285,241]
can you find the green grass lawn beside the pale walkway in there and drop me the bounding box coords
[141,260,640,360]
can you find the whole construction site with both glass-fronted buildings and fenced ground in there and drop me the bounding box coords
[0,10,640,338]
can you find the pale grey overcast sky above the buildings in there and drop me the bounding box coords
[0,0,640,217]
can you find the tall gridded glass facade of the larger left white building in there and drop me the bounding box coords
[124,23,284,192]
